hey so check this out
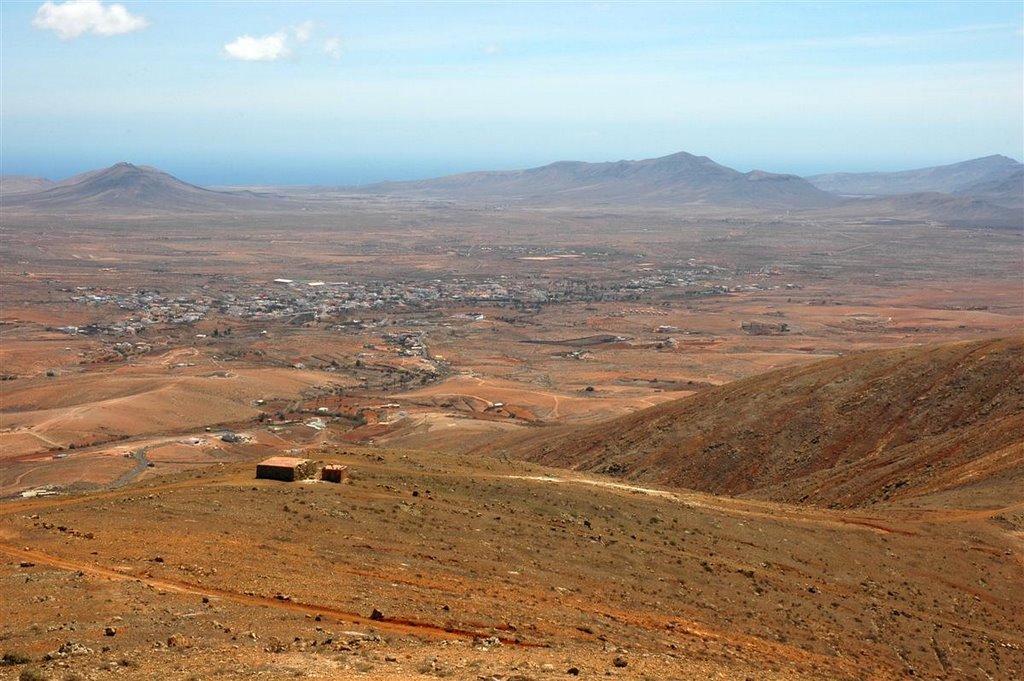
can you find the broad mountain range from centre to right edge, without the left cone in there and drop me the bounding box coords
[349,152,1024,228]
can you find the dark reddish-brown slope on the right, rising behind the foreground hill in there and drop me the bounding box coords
[507,339,1024,507]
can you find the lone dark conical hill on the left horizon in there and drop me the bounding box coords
[0,163,276,213]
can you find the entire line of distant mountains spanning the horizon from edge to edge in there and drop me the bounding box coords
[0,152,1024,228]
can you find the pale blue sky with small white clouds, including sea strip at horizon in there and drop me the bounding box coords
[0,0,1024,184]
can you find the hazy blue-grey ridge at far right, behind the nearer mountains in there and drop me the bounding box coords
[807,155,1024,199]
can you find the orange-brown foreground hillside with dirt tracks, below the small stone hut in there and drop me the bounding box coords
[0,448,1024,681]
